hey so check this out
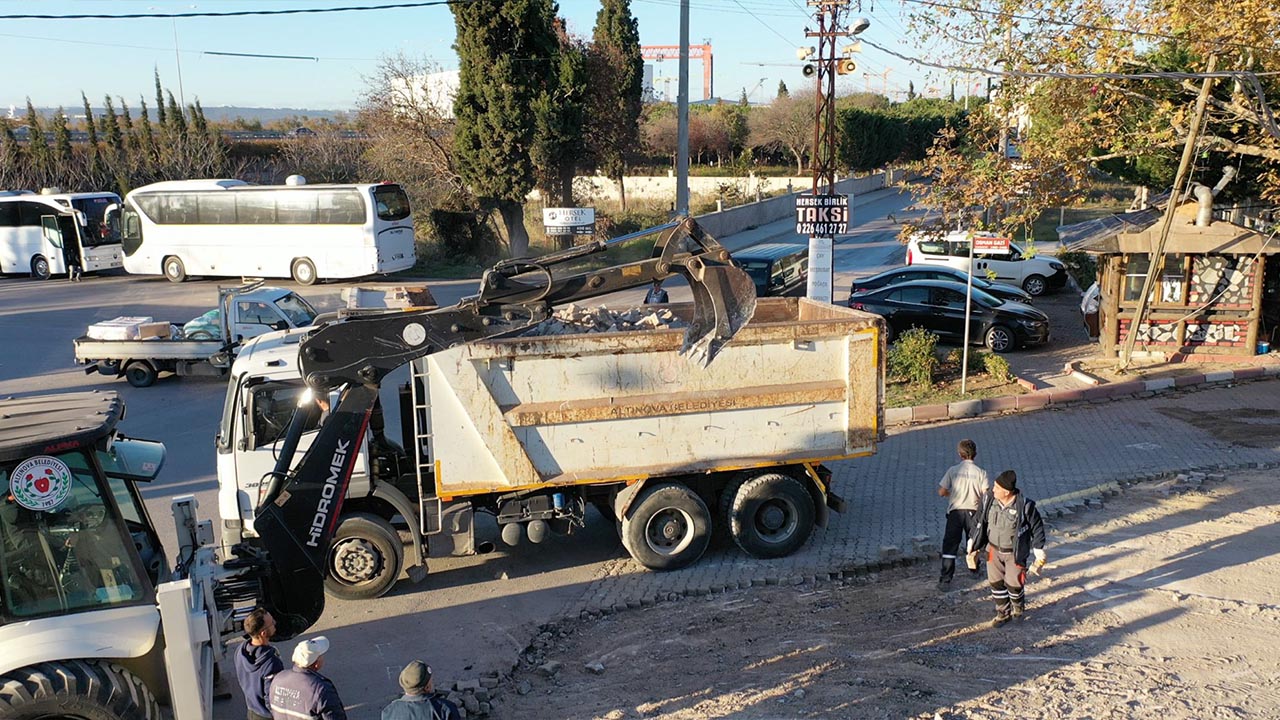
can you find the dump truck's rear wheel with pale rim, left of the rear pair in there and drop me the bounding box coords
[622,483,712,570]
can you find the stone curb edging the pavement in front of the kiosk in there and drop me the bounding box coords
[884,364,1280,427]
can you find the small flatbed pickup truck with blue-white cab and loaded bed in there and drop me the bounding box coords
[74,282,316,387]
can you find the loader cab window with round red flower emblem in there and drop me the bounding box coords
[0,451,150,620]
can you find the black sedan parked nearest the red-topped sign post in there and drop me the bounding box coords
[850,281,1048,352]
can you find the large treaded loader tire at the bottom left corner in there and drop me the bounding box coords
[0,660,163,720]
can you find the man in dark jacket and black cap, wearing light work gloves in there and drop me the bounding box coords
[972,470,1044,628]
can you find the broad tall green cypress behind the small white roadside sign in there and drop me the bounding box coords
[449,0,559,256]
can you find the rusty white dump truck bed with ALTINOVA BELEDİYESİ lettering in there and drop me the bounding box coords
[420,299,884,497]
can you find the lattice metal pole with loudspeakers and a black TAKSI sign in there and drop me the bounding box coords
[796,0,870,302]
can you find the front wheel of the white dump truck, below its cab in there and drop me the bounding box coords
[324,512,404,600]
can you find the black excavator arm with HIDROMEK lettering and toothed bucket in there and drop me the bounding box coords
[245,218,755,638]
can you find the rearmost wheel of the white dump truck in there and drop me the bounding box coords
[728,473,814,557]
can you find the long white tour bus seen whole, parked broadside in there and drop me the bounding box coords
[120,176,416,284]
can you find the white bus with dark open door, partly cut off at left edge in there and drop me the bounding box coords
[0,190,123,279]
